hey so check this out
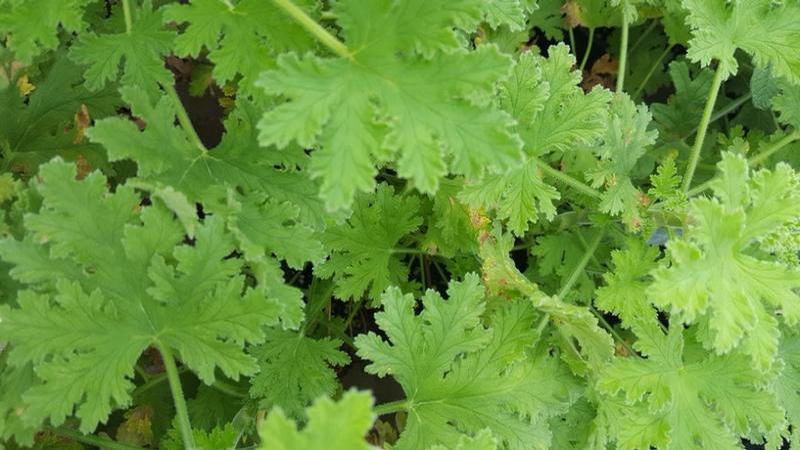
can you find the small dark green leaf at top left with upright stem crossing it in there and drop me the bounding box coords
[70,0,175,94]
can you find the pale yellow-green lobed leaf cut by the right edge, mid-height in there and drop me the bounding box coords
[648,153,800,370]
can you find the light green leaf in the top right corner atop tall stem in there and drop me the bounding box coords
[683,0,800,84]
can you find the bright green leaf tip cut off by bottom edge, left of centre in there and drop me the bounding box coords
[259,391,375,450]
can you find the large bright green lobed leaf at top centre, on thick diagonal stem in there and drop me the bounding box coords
[258,0,520,210]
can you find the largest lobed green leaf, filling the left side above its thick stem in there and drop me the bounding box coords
[0,160,284,432]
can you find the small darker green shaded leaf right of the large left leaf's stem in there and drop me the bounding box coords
[250,329,350,418]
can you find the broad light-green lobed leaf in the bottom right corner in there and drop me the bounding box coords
[597,325,786,450]
